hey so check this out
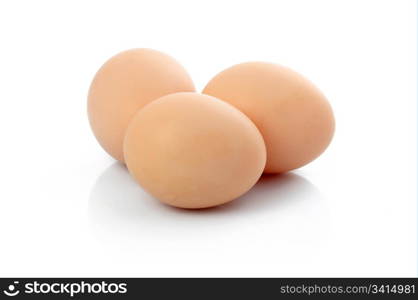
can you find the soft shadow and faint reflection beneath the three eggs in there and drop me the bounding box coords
[88,163,327,245]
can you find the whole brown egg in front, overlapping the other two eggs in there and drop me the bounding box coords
[124,93,266,208]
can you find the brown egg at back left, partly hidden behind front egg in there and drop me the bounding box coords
[88,49,195,162]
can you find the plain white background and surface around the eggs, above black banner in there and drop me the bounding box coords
[0,0,417,277]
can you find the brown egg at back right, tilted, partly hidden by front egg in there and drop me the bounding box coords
[203,62,334,173]
